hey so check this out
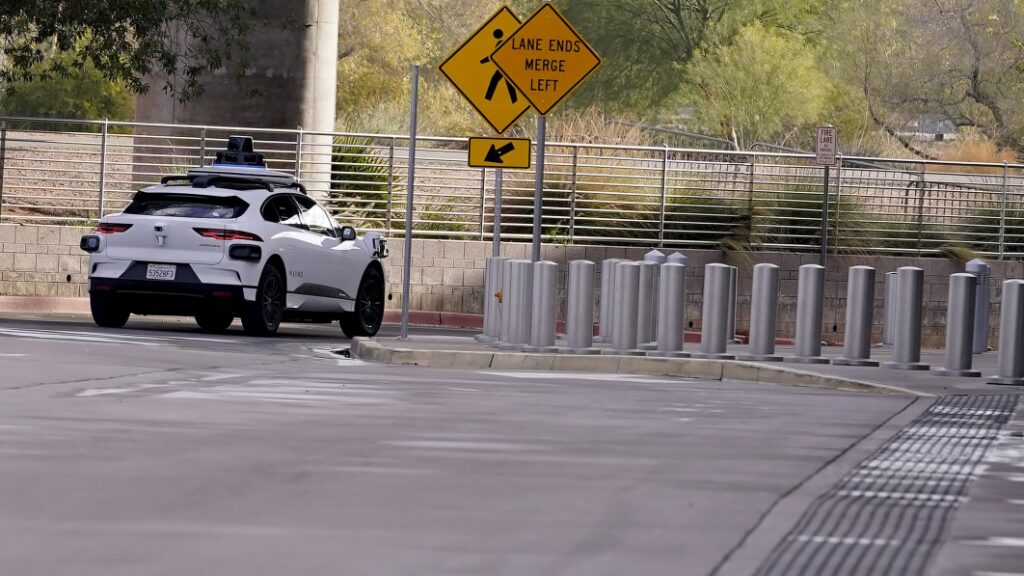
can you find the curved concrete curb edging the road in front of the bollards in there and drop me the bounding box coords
[350,338,930,397]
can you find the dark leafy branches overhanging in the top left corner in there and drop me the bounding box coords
[0,0,258,100]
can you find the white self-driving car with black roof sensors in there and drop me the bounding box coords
[81,136,387,336]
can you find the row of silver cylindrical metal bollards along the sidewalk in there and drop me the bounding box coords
[478,251,1024,385]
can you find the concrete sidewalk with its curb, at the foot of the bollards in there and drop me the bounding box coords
[350,336,1024,397]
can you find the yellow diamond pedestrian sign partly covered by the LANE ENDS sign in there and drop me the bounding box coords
[440,6,529,133]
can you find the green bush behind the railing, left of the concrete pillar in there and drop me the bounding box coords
[0,48,134,120]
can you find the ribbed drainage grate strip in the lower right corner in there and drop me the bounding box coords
[756,395,1019,576]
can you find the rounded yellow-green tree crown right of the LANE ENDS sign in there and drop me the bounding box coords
[688,24,828,148]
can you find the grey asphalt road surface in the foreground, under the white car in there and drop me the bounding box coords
[0,316,1015,576]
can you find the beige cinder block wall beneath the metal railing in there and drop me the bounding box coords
[0,223,1024,347]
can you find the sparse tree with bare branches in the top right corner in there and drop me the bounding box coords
[827,0,1024,156]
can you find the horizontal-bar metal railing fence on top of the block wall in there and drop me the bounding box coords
[0,118,1024,258]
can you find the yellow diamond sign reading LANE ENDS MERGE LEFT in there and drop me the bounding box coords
[490,3,601,116]
